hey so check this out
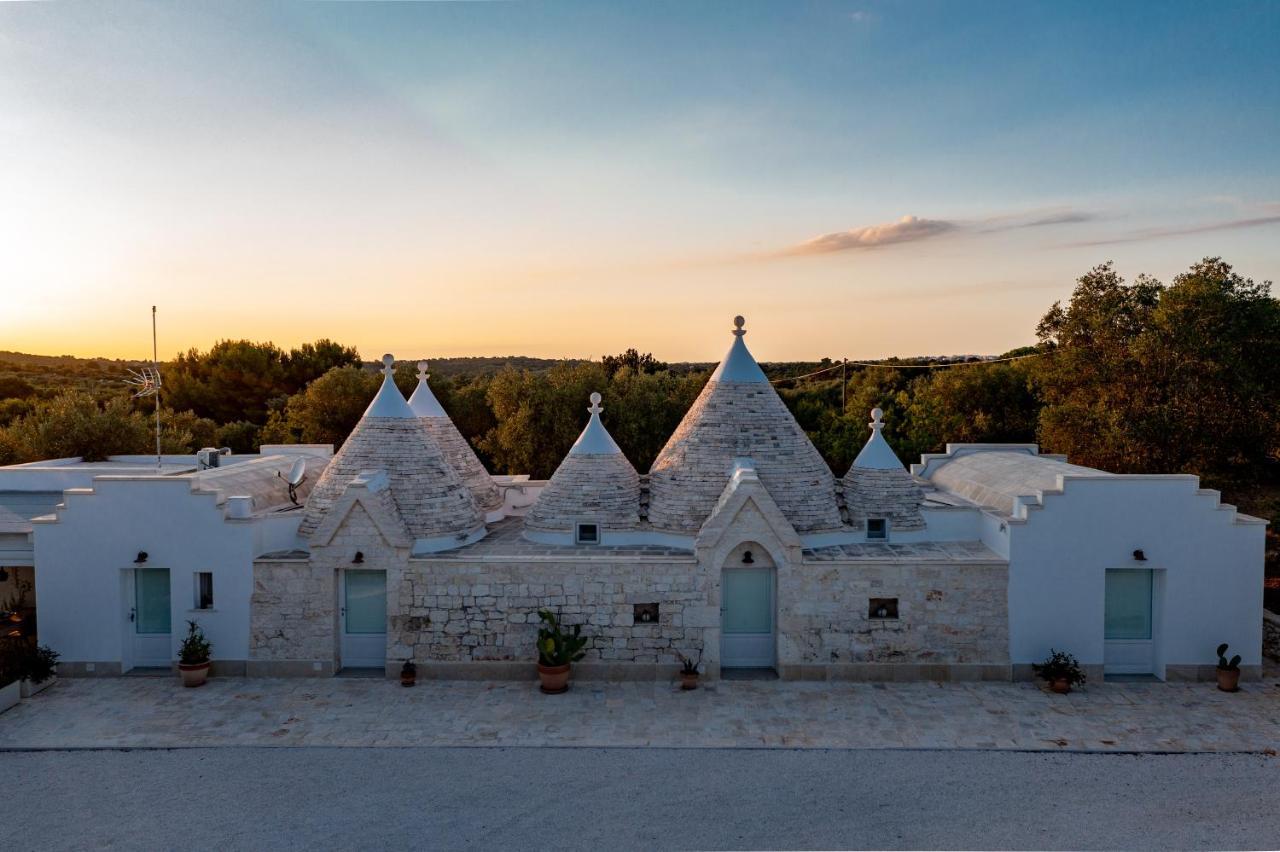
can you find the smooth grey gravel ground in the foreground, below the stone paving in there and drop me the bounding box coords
[0,748,1280,851]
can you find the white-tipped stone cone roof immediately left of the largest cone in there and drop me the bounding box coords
[525,394,640,532]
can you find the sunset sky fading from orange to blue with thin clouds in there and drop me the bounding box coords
[0,1,1280,361]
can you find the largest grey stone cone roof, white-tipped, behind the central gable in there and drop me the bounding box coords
[649,317,841,532]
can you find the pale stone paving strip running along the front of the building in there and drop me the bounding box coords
[0,673,1280,752]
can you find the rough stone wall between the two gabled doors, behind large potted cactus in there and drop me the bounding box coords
[388,560,719,664]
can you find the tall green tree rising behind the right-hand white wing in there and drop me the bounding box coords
[1033,257,1280,473]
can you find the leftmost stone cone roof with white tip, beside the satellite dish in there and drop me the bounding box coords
[298,356,484,540]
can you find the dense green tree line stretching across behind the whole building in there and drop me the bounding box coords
[0,258,1280,493]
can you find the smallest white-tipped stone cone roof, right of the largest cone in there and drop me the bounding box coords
[841,408,924,531]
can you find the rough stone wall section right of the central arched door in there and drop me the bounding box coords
[778,563,1009,664]
